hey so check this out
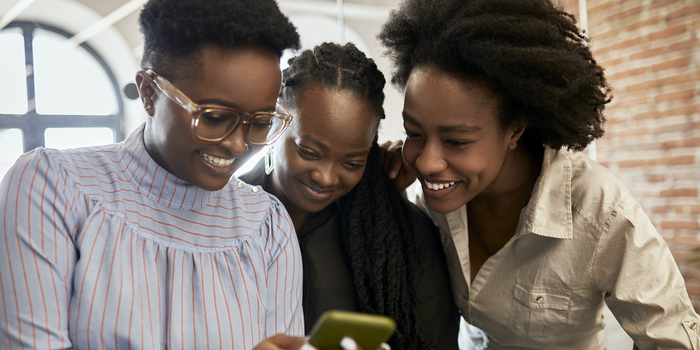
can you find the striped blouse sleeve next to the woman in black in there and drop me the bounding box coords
[263,198,304,336]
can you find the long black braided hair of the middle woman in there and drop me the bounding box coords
[280,43,434,350]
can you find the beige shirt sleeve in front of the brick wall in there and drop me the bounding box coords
[594,198,700,350]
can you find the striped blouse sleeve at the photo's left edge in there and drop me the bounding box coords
[0,149,77,349]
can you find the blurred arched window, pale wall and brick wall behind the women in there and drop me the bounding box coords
[0,0,700,349]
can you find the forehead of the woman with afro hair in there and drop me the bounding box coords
[404,66,499,127]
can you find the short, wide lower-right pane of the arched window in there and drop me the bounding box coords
[44,128,116,149]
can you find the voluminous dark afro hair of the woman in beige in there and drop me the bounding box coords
[378,0,611,151]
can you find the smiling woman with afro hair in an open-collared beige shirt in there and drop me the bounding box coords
[379,0,700,349]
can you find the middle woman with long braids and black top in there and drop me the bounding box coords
[240,43,459,350]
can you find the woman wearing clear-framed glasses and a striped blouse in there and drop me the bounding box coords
[0,0,314,349]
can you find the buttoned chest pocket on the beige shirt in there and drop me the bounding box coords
[508,280,571,337]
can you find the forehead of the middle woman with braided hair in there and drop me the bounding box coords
[292,84,379,148]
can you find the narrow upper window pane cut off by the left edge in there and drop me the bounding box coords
[0,28,27,114]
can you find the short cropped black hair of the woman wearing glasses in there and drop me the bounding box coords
[139,0,300,80]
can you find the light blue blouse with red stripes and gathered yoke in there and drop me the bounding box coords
[0,126,304,349]
